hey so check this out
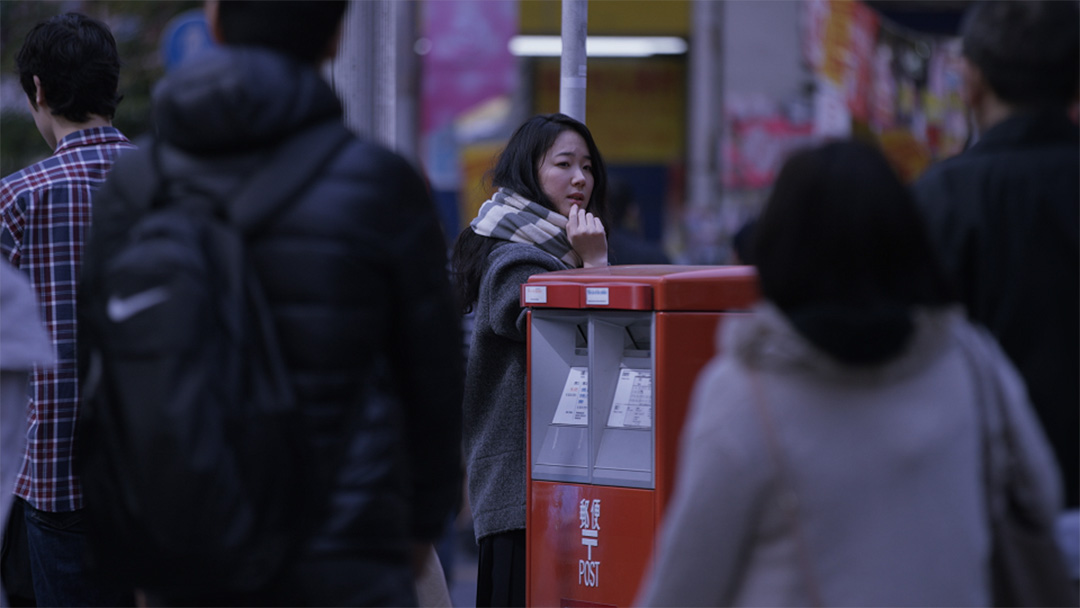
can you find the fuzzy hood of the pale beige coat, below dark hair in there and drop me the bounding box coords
[717,302,962,383]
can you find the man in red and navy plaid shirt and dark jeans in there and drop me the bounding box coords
[0,13,133,606]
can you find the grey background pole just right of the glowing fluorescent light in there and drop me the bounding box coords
[687,0,724,214]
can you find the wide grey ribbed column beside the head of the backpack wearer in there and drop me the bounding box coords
[328,0,419,163]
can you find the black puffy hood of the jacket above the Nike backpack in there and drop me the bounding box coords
[153,46,341,153]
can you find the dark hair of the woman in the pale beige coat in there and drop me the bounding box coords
[752,140,955,365]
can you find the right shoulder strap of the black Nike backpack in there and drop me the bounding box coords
[227,118,353,235]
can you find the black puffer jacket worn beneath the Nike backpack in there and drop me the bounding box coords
[94,48,463,605]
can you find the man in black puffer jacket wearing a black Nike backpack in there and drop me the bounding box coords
[80,1,463,606]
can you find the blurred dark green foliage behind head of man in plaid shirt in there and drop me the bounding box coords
[0,0,202,175]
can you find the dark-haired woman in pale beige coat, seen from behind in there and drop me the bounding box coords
[638,141,1059,606]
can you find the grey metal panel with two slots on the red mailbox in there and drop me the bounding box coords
[528,309,656,488]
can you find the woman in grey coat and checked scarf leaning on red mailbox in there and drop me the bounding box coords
[451,113,607,606]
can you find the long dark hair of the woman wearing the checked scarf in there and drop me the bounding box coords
[450,113,610,312]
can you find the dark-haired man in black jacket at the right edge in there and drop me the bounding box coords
[915,1,1080,579]
